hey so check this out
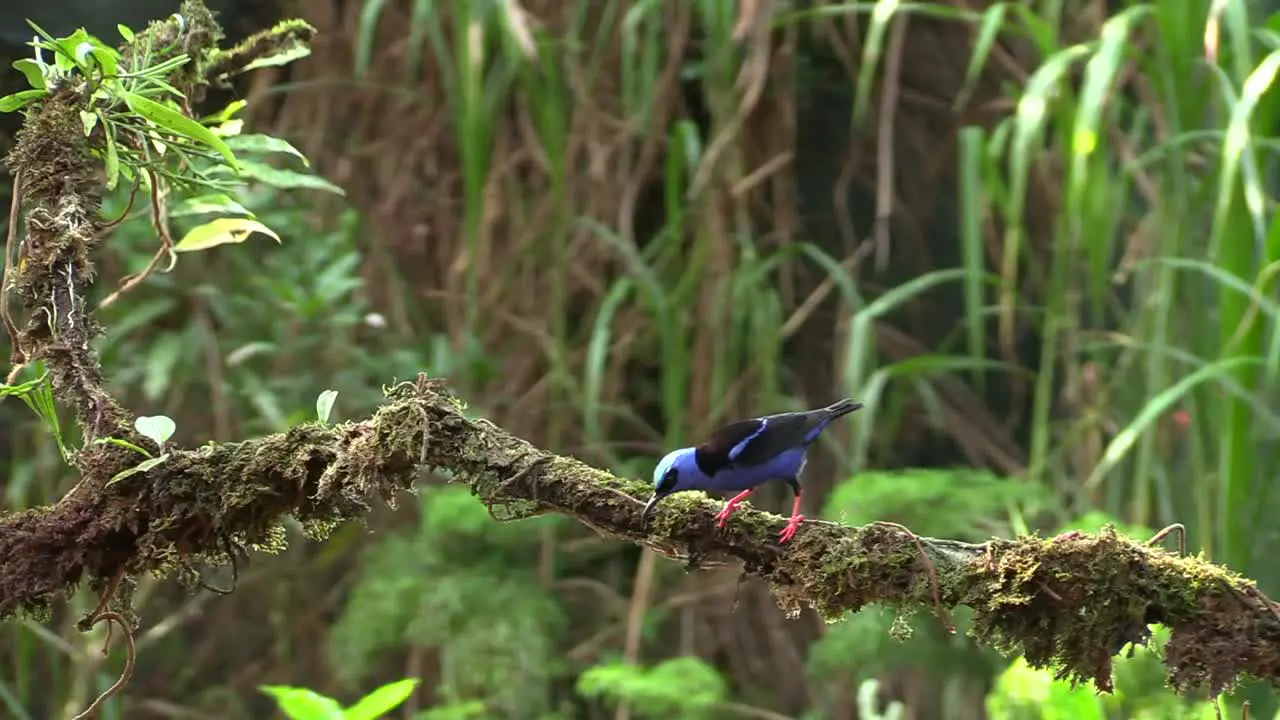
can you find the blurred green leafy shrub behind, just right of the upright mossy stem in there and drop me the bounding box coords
[101,183,422,430]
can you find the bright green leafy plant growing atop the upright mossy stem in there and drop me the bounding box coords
[0,13,342,316]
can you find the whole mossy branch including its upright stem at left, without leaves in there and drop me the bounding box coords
[0,0,1280,692]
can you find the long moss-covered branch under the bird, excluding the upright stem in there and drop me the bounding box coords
[0,379,1280,691]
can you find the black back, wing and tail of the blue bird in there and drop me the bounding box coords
[695,398,863,477]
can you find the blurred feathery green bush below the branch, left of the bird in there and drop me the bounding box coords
[330,487,568,717]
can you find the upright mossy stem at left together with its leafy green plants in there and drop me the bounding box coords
[0,0,342,716]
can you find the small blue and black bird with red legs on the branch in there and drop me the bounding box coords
[640,398,863,542]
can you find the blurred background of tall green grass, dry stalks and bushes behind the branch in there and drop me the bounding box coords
[0,0,1280,720]
